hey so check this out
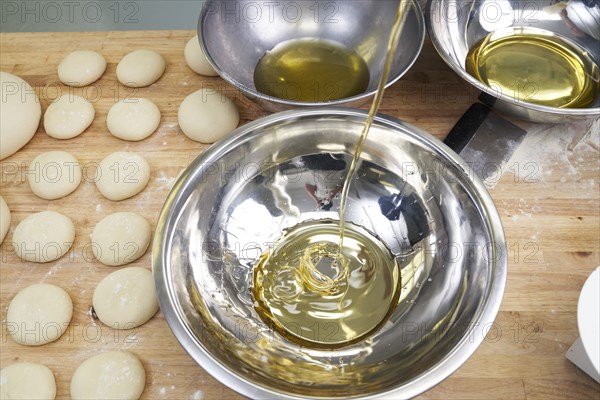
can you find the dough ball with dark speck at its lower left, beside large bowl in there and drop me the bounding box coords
[93,267,158,329]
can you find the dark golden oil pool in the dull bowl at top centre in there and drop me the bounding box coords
[254,39,370,102]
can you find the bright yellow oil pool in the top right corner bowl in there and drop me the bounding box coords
[466,28,600,108]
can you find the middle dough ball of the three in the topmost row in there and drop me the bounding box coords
[117,49,166,87]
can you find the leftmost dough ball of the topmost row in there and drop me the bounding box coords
[58,50,106,87]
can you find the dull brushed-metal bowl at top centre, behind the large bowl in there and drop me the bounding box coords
[198,0,425,111]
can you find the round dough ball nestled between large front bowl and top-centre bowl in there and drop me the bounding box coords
[178,89,240,143]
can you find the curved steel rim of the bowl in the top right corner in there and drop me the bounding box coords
[425,0,600,116]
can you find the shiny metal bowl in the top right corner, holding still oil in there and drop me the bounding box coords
[426,0,600,122]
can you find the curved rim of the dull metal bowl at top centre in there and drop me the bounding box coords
[198,1,426,107]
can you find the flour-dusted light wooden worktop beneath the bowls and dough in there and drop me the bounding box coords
[0,31,600,400]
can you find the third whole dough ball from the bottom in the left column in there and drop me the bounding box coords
[13,211,75,263]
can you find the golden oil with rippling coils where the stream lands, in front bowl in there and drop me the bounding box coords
[252,220,401,349]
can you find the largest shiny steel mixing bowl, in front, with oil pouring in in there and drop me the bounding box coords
[153,108,507,399]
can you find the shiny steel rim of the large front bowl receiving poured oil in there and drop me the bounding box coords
[152,108,507,400]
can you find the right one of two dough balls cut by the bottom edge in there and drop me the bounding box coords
[71,351,146,400]
